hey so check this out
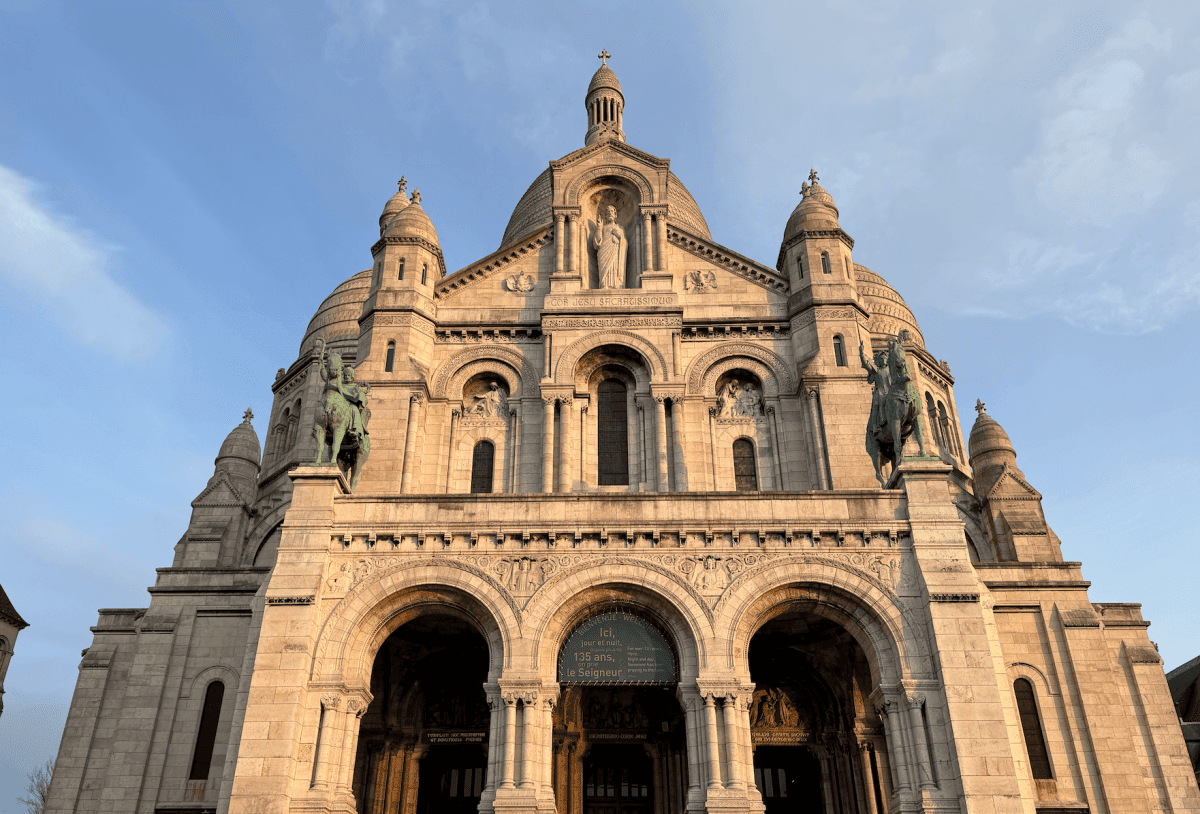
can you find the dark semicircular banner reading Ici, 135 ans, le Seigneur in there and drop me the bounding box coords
[558,611,679,684]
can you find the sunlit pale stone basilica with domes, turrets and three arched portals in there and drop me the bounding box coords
[48,59,1200,814]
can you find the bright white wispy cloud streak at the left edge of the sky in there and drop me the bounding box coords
[0,166,167,359]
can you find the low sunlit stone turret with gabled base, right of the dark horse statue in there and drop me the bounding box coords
[967,401,1062,562]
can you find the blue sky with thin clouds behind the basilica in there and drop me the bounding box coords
[0,0,1200,810]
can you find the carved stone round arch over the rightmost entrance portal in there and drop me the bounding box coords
[716,557,928,686]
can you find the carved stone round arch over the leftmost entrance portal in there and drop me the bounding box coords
[310,559,521,688]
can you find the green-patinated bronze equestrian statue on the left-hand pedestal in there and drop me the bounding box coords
[312,340,371,492]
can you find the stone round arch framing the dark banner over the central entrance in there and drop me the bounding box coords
[524,557,713,683]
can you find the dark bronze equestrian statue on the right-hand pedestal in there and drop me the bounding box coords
[858,333,926,486]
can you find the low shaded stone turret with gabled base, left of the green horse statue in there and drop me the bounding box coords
[173,409,259,567]
